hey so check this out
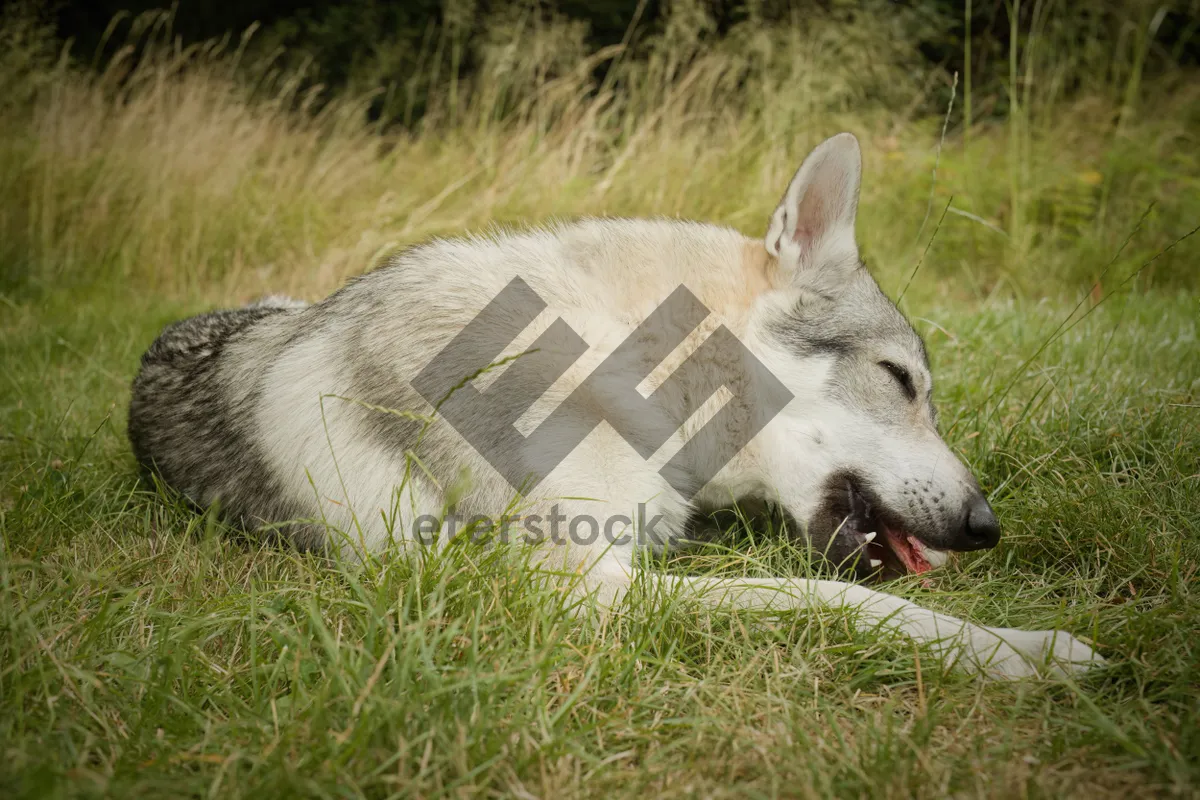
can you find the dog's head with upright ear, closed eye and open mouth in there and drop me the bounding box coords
[734,133,1000,577]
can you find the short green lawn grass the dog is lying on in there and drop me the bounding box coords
[0,284,1200,796]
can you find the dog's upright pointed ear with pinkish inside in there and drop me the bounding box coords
[766,133,863,289]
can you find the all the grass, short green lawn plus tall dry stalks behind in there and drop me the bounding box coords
[0,3,1200,798]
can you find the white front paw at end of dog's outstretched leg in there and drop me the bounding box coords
[968,627,1104,680]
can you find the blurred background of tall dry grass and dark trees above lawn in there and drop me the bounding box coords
[0,0,1200,299]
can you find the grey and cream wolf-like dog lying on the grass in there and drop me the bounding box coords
[128,133,1102,678]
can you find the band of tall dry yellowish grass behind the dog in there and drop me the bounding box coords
[0,4,1200,303]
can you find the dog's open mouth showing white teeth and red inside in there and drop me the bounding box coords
[835,480,947,579]
